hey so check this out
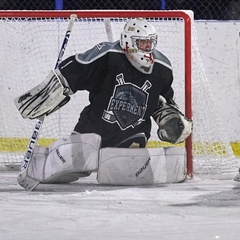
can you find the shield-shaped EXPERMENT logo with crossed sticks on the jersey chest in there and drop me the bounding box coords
[102,73,152,130]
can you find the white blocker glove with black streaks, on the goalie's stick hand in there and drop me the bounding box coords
[14,70,71,119]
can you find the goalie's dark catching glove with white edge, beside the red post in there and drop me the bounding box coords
[153,96,192,144]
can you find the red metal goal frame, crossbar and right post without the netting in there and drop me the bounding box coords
[0,10,193,177]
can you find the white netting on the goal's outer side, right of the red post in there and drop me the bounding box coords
[192,23,239,175]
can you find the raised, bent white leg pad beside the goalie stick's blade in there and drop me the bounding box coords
[28,133,101,183]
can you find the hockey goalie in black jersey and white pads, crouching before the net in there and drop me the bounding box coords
[15,19,192,188]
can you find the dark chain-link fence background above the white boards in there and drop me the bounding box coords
[0,0,240,20]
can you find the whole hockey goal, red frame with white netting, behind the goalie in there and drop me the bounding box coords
[0,11,238,175]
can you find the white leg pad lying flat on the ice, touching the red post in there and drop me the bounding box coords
[97,147,186,185]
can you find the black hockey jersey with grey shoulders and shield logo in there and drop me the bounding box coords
[59,41,173,147]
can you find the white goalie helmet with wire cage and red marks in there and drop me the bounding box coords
[120,18,157,74]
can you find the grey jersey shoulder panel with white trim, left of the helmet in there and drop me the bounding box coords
[76,41,124,64]
